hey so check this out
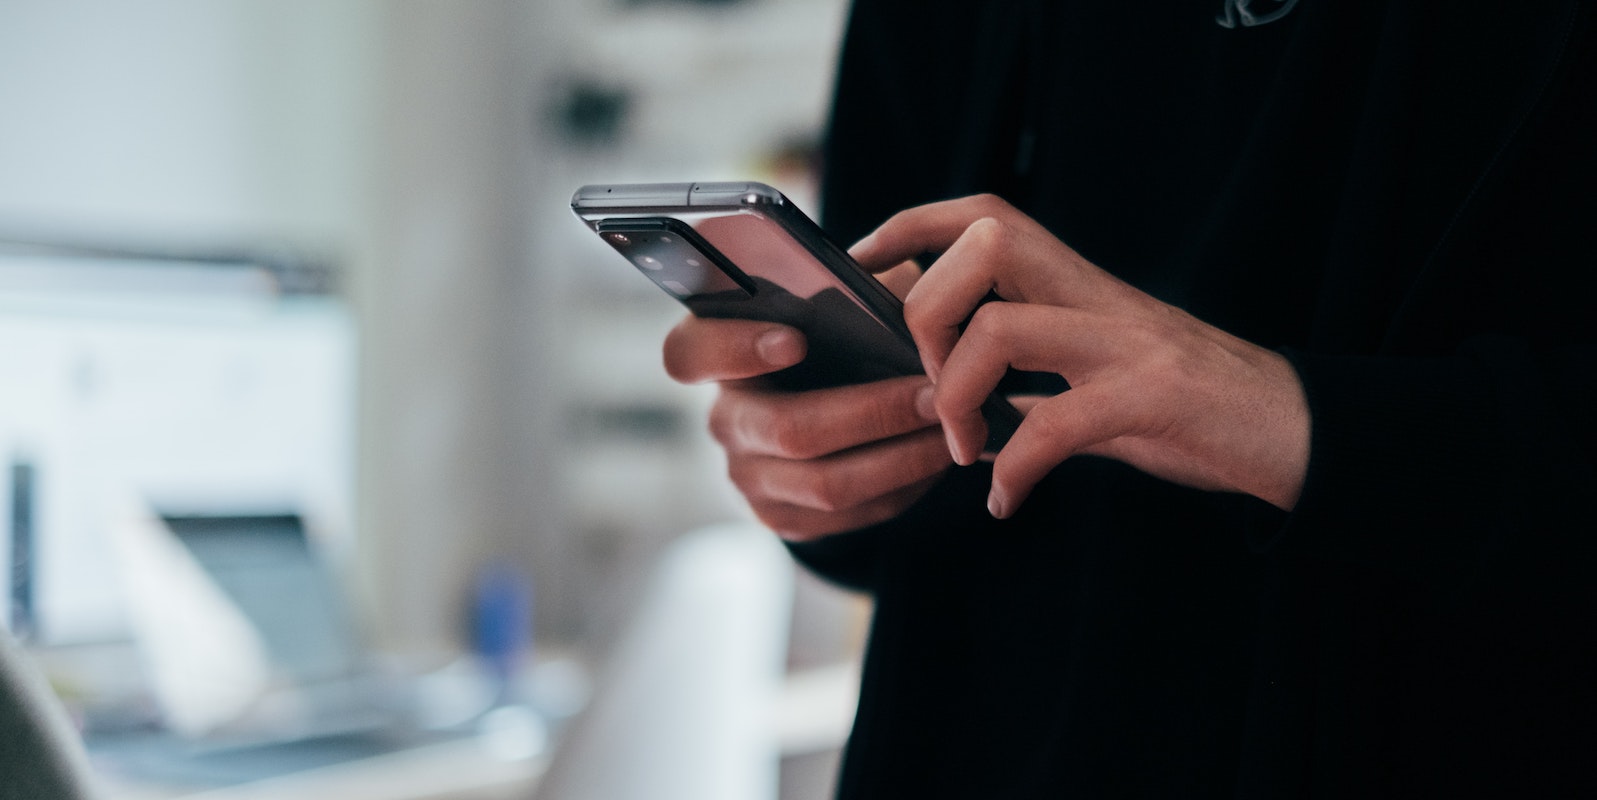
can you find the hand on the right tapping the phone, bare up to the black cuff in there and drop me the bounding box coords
[851,196,1310,517]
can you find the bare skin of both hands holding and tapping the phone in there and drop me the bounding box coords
[664,195,1310,540]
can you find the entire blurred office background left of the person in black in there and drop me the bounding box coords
[0,0,869,798]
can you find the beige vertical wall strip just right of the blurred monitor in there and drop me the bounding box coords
[355,0,554,651]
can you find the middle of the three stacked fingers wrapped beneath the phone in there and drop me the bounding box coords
[728,430,953,511]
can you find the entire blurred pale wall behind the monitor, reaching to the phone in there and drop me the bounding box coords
[0,0,845,653]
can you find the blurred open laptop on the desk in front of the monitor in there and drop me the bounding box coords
[89,511,454,786]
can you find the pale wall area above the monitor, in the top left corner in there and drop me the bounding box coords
[0,0,372,244]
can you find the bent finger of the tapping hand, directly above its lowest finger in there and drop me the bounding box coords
[934,302,1123,465]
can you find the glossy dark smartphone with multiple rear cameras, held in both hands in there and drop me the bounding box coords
[572,182,1020,453]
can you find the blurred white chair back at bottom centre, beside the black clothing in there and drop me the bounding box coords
[537,524,794,800]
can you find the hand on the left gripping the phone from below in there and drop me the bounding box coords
[664,265,953,541]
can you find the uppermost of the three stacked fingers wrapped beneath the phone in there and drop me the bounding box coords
[709,375,937,458]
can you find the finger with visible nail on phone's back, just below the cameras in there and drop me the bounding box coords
[664,316,806,383]
